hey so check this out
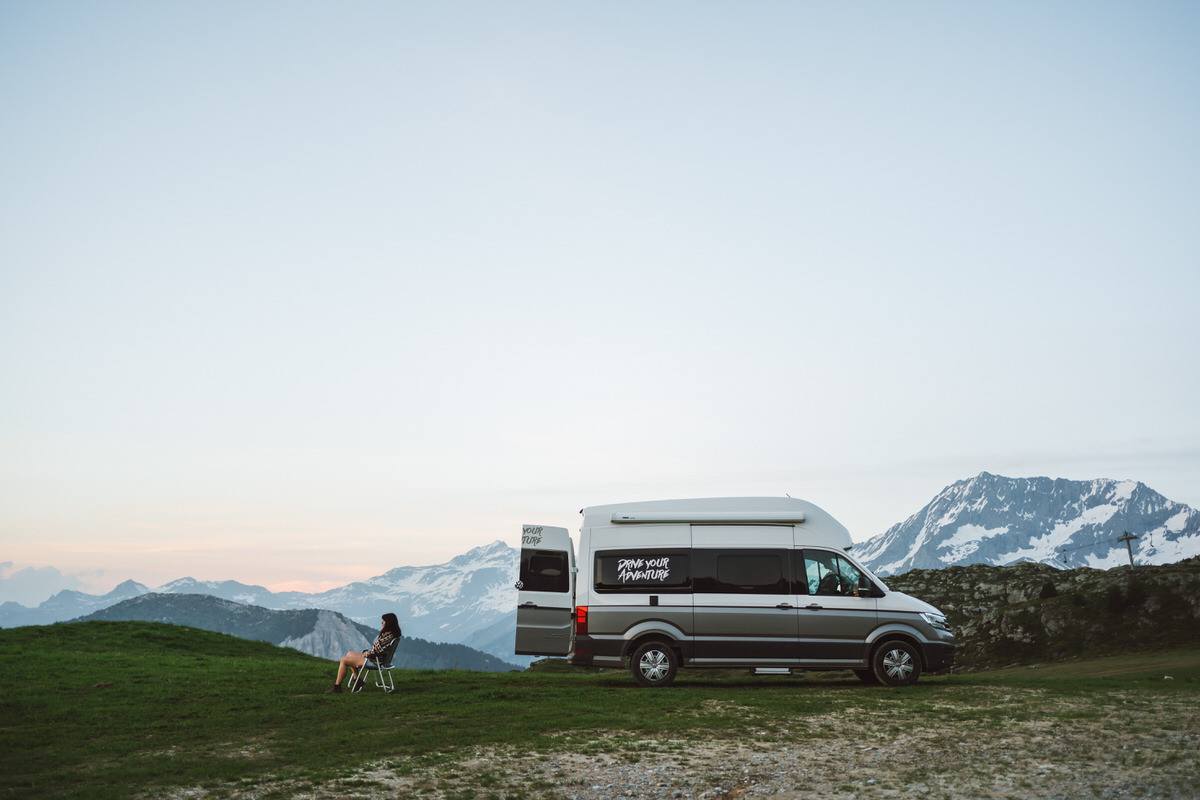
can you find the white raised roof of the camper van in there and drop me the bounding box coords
[581,498,851,549]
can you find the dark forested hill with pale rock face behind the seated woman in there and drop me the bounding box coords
[72,593,515,672]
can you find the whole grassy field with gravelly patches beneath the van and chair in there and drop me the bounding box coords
[0,622,1200,798]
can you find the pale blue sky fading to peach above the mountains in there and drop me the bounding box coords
[0,0,1200,600]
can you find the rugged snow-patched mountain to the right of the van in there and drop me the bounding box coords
[852,473,1200,576]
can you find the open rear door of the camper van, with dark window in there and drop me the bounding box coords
[514,525,575,656]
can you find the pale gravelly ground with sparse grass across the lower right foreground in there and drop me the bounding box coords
[179,687,1200,800]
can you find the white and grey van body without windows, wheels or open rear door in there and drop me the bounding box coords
[530,498,954,669]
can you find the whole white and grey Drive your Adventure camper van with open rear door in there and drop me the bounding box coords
[516,498,954,686]
